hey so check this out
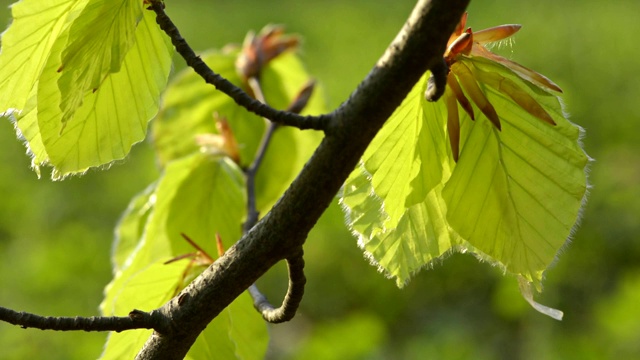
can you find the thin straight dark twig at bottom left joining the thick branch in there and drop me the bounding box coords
[0,306,162,332]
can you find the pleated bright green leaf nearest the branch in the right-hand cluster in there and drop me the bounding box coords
[341,76,468,286]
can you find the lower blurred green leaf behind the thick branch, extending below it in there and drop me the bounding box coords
[101,153,269,359]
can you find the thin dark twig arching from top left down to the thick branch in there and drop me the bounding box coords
[149,0,329,130]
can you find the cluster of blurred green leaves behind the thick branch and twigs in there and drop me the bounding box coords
[101,40,325,359]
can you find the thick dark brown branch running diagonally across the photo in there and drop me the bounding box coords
[137,0,469,359]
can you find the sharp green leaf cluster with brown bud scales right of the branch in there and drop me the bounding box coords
[342,15,589,318]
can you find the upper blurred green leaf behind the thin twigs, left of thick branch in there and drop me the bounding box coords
[153,51,325,213]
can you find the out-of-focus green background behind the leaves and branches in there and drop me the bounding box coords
[0,0,640,359]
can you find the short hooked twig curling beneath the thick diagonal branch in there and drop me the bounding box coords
[249,248,307,324]
